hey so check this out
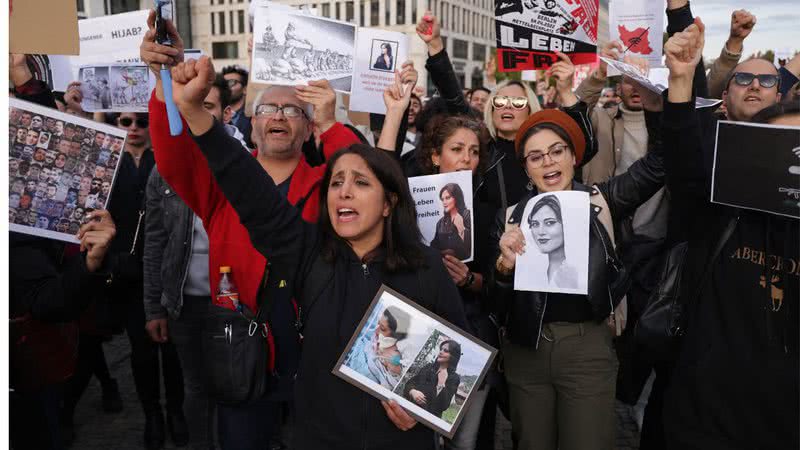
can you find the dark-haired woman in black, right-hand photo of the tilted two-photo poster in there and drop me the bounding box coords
[403,340,461,417]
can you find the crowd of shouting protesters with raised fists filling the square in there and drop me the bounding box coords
[9,0,800,450]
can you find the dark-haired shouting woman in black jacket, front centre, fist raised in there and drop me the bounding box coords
[172,57,466,450]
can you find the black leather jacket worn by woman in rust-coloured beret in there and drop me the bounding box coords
[490,109,664,347]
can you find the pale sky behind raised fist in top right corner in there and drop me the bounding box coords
[691,0,800,59]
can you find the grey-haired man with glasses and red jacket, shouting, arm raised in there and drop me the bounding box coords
[140,8,359,450]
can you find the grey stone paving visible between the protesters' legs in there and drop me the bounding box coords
[72,336,639,450]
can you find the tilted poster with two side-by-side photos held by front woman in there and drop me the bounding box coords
[333,285,497,438]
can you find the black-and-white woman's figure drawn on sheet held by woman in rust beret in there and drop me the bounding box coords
[528,195,578,289]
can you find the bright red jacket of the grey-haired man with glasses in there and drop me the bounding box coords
[149,94,360,311]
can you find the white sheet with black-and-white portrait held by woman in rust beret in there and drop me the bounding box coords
[514,191,590,295]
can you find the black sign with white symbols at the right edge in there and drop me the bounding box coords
[711,120,800,219]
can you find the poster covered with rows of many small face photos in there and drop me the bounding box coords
[8,98,125,243]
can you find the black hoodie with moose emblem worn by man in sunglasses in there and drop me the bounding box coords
[663,96,800,450]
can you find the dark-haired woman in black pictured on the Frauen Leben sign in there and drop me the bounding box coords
[431,183,472,260]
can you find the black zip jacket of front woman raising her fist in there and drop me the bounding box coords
[195,119,467,450]
